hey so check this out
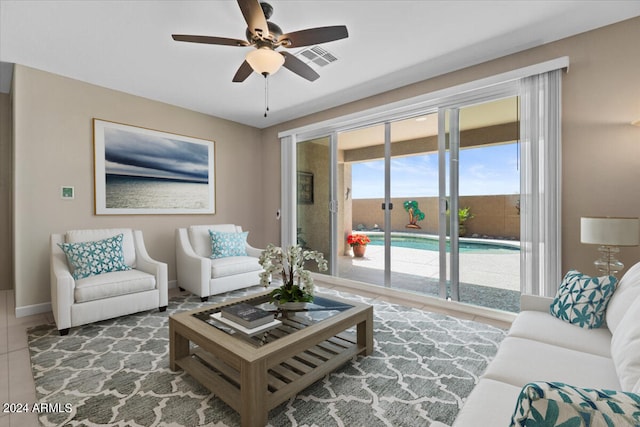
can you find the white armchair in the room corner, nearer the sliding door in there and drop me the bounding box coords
[176,224,262,301]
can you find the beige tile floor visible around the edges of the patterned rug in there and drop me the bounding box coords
[0,283,510,427]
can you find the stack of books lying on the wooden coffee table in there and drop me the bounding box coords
[211,303,282,335]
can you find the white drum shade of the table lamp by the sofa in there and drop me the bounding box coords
[580,217,640,246]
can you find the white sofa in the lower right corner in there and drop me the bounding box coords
[444,263,640,427]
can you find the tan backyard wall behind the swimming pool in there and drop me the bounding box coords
[352,194,520,240]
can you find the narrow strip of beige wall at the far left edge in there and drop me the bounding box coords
[0,93,13,290]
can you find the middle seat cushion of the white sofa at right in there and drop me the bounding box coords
[483,336,620,392]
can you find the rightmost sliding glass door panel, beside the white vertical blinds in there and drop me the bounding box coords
[440,96,520,312]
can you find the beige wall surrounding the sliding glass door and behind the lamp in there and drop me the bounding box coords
[262,18,640,280]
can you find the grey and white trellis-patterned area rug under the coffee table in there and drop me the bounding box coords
[28,287,505,427]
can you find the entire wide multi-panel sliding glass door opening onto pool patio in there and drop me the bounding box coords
[281,61,560,311]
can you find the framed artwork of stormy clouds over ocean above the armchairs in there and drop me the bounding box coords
[93,119,215,215]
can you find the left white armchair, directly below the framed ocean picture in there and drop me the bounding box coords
[50,229,169,335]
